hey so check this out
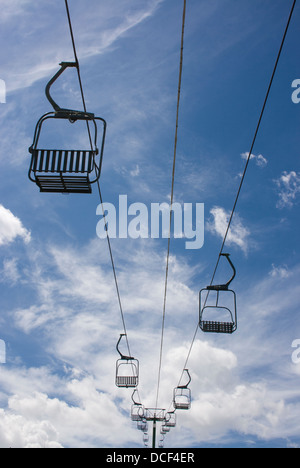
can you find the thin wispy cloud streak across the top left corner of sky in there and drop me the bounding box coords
[0,0,164,92]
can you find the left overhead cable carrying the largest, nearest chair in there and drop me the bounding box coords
[65,0,131,356]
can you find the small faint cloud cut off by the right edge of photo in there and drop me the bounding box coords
[274,171,300,209]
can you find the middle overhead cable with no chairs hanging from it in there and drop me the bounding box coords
[155,0,186,408]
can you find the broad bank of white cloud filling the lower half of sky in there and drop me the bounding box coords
[0,234,299,447]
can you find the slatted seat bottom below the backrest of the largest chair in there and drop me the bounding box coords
[36,174,92,193]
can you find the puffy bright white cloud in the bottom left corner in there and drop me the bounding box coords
[0,377,138,448]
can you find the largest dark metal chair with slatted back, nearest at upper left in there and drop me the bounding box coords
[28,62,106,193]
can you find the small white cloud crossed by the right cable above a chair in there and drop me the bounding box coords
[207,207,250,253]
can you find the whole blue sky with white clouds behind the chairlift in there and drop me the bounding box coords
[0,0,300,448]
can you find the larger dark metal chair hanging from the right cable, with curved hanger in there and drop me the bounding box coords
[199,254,237,334]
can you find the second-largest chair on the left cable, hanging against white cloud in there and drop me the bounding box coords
[116,334,139,388]
